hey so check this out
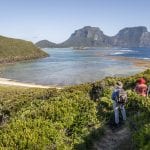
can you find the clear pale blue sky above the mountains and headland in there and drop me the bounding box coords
[0,0,150,43]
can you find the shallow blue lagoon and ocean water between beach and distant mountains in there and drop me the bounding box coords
[0,48,150,86]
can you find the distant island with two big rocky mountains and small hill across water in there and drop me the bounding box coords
[35,26,150,49]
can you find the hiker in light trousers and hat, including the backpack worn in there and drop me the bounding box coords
[112,81,127,127]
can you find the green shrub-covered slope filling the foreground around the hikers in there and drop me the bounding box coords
[0,70,150,150]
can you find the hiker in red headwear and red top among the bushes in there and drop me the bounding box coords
[134,78,148,96]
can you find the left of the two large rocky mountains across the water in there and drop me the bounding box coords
[60,26,110,47]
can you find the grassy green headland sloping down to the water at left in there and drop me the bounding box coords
[0,36,48,63]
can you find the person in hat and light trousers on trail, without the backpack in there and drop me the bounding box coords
[112,81,126,127]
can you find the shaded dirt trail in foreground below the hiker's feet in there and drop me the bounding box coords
[93,126,132,150]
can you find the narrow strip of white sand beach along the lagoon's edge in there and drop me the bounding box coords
[0,78,61,89]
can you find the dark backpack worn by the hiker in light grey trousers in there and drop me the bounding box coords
[115,89,128,104]
